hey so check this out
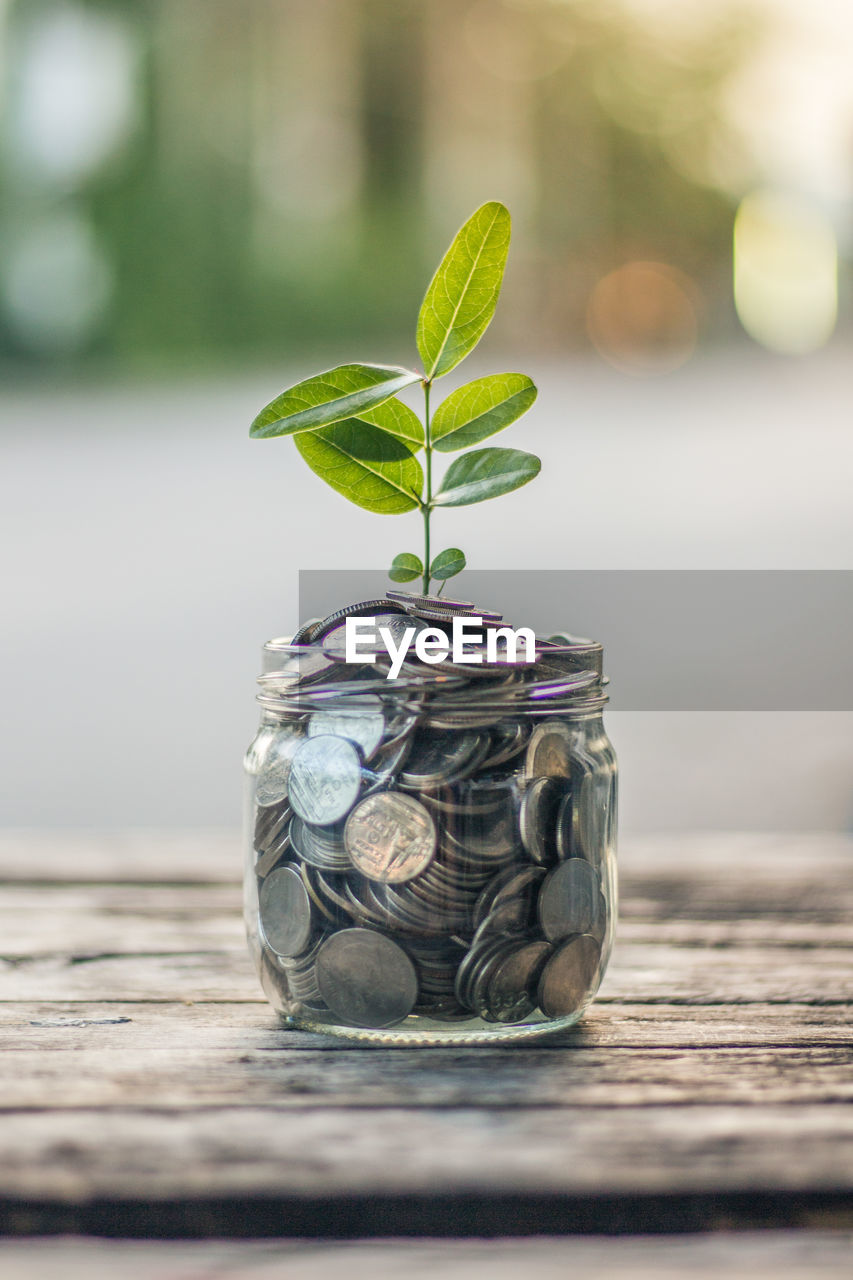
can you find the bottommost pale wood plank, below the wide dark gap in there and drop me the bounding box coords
[0,1231,853,1280]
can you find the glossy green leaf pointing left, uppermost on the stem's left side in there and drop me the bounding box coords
[248,365,420,440]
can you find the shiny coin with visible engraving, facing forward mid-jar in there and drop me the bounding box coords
[343,791,435,884]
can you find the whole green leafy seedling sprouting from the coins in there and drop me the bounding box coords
[250,201,542,591]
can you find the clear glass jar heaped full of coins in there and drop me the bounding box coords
[245,593,616,1046]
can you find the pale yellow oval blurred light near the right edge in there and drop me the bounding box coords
[734,191,838,355]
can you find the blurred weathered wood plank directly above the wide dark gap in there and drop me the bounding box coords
[0,1097,853,1203]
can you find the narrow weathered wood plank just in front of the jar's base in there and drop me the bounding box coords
[0,1039,853,1112]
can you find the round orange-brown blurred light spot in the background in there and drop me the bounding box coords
[587,262,699,374]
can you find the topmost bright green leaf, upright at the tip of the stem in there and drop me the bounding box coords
[418,200,510,378]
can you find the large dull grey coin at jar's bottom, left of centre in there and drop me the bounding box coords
[315,929,418,1027]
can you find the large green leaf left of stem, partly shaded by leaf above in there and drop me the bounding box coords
[296,417,424,515]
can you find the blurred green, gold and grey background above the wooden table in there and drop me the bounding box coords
[0,0,853,832]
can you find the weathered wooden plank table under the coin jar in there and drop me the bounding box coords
[0,832,853,1280]
